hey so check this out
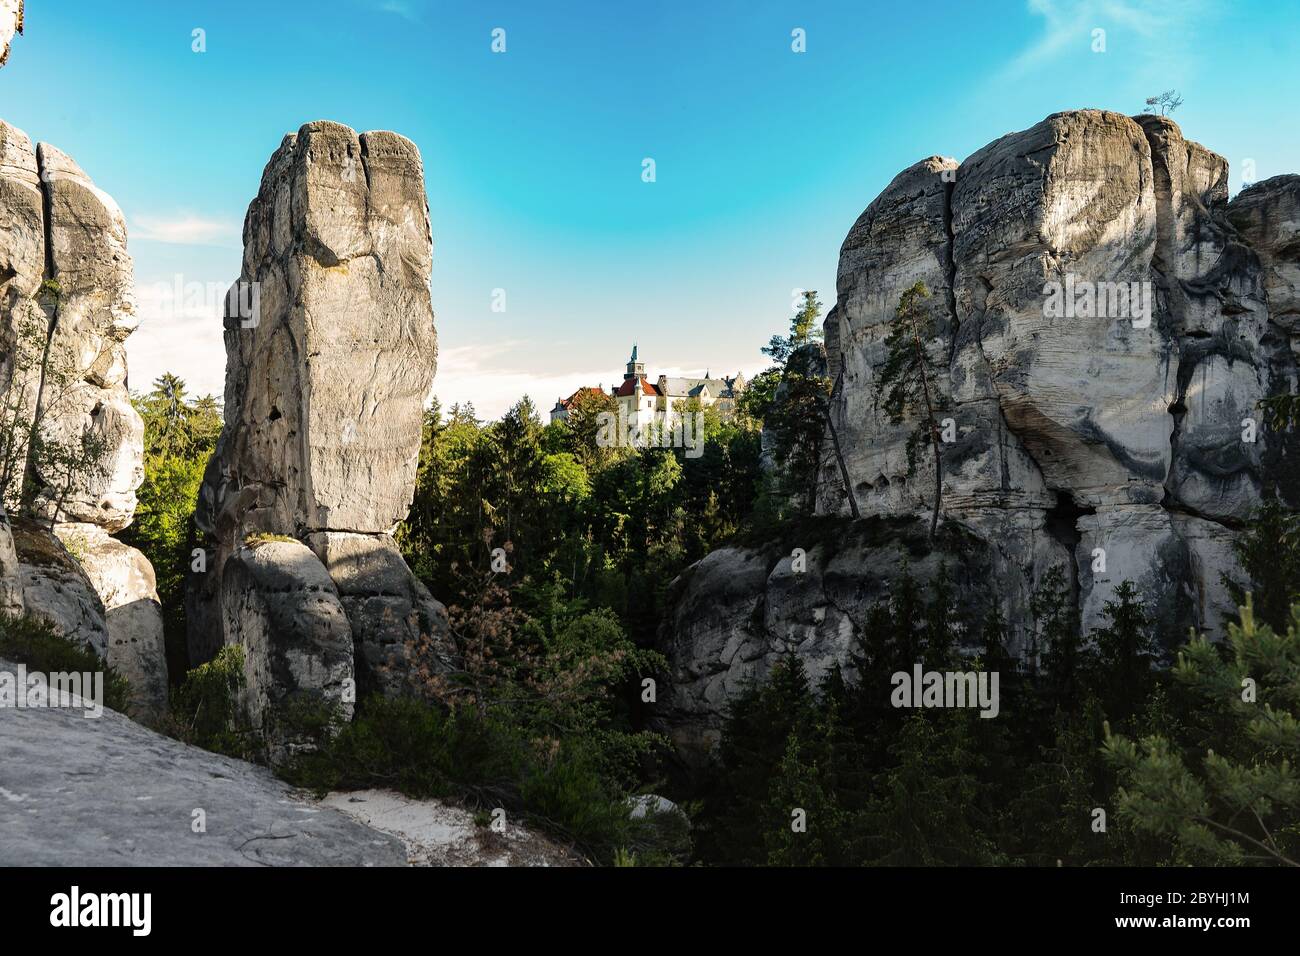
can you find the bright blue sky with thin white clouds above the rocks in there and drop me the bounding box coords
[0,0,1300,416]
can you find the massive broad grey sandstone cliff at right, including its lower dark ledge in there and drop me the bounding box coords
[663,111,1300,764]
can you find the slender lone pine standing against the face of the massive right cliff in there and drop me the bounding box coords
[878,282,944,538]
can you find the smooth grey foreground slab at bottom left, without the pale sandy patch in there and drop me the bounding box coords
[0,661,407,866]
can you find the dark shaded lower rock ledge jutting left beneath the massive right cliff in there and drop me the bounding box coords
[658,516,993,762]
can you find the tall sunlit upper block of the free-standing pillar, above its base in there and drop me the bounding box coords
[200,122,437,546]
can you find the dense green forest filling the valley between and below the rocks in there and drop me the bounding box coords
[48,293,1300,866]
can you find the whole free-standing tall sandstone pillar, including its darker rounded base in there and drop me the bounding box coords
[186,122,446,764]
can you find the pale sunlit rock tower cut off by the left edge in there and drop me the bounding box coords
[0,115,166,719]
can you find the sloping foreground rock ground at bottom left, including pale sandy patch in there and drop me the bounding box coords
[0,658,582,866]
